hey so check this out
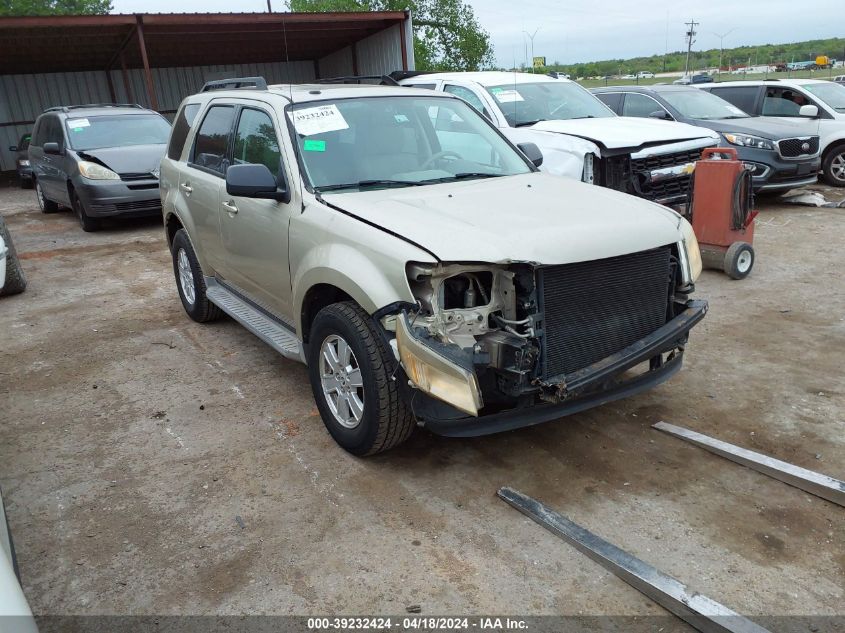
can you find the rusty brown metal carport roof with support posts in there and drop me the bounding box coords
[0,11,409,108]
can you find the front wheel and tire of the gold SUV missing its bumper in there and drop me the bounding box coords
[308,302,414,456]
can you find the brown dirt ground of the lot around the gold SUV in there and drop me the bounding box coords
[0,180,845,630]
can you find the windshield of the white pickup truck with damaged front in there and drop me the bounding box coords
[487,81,616,127]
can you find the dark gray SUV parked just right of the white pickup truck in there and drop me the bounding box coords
[593,85,821,192]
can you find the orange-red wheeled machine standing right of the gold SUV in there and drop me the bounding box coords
[690,147,757,279]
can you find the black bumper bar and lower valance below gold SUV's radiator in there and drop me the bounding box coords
[412,301,707,437]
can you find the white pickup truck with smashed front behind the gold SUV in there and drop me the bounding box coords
[397,71,719,205]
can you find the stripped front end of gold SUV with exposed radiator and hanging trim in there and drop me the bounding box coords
[384,238,707,436]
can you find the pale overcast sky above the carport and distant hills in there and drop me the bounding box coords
[113,0,845,67]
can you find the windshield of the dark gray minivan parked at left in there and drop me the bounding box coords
[65,114,170,150]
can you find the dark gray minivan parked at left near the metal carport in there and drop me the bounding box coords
[29,104,170,231]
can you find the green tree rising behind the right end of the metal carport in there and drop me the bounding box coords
[288,0,493,70]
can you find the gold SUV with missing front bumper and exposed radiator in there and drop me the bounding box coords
[161,78,707,455]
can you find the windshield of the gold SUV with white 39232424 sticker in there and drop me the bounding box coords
[288,97,531,191]
